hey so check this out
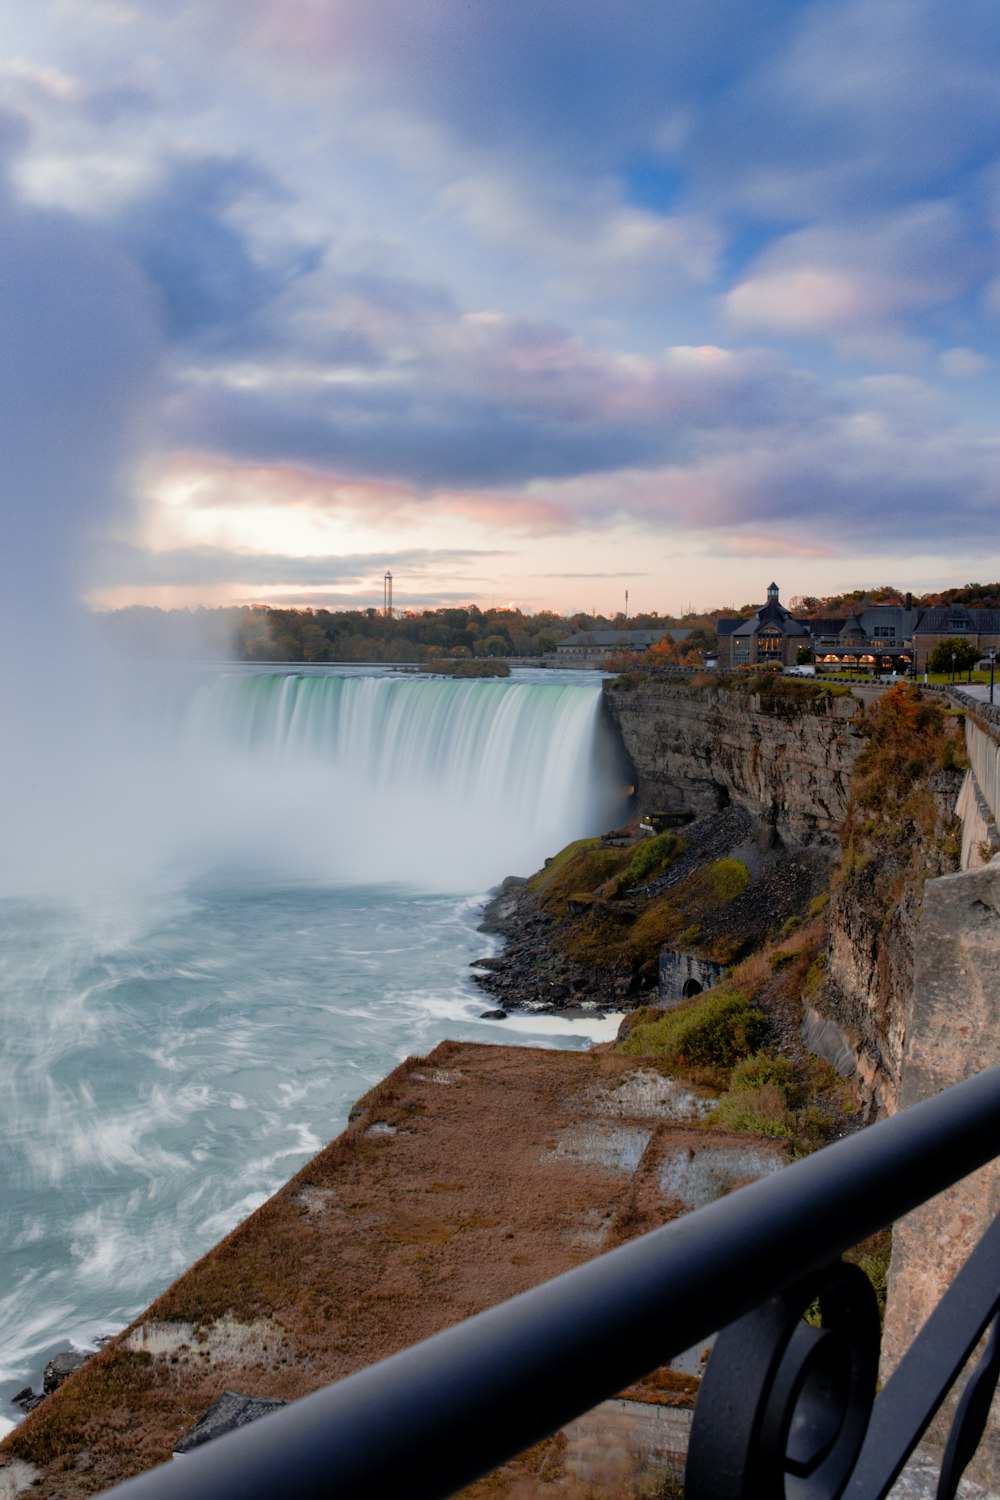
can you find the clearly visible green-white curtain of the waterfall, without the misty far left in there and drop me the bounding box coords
[169,672,622,890]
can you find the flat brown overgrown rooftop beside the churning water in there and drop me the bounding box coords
[0,1043,784,1500]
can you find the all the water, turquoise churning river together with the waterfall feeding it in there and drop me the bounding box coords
[0,668,621,1431]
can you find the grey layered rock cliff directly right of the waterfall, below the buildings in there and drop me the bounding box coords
[604,677,862,845]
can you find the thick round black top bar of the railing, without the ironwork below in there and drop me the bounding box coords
[107,1067,1000,1500]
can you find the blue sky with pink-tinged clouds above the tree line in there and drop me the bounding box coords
[0,0,1000,612]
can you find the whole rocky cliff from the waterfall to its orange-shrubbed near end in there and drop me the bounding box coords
[606,678,963,1115]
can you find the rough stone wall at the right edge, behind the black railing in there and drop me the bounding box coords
[882,860,1000,1488]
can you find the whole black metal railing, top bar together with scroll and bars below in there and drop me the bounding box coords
[107,1067,1000,1500]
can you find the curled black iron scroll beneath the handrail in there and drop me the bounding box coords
[685,1262,880,1500]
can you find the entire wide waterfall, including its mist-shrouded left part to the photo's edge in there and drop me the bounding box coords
[0,666,624,899]
